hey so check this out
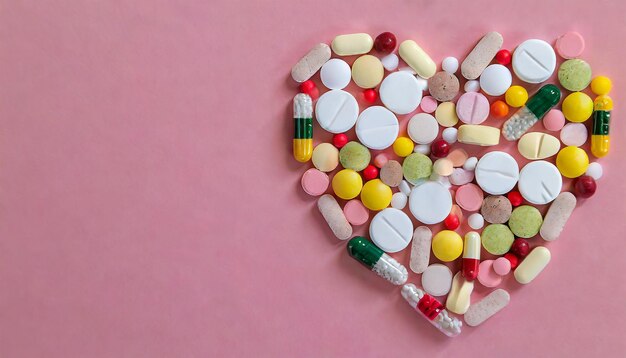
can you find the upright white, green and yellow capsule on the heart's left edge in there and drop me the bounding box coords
[293,93,313,163]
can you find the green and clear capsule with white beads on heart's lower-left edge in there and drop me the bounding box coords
[348,236,409,286]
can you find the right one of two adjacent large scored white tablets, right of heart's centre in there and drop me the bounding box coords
[517,160,563,205]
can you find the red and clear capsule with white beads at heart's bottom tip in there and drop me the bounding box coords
[402,283,463,337]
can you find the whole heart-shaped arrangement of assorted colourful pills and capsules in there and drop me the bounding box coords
[291,31,613,337]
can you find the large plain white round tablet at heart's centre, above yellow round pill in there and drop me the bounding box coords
[409,181,452,225]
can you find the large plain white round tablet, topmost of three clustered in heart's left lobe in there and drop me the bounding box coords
[378,71,422,114]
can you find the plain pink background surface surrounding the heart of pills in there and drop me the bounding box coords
[0,0,626,357]
